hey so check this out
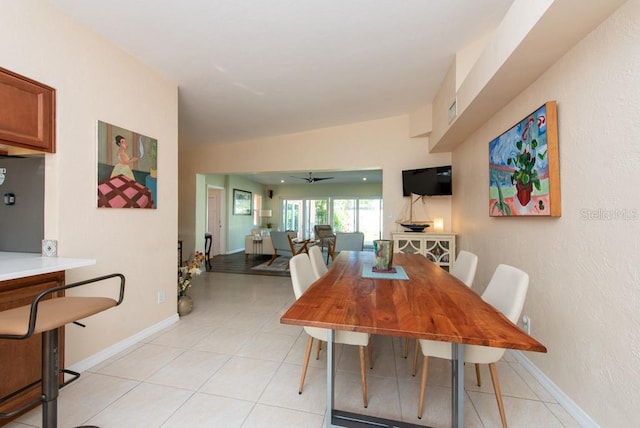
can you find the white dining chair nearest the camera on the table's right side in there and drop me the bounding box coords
[418,264,529,427]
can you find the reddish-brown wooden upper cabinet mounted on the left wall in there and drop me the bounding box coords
[0,68,56,153]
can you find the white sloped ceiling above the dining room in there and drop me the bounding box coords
[49,0,513,145]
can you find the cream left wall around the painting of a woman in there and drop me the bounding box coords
[0,0,178,365]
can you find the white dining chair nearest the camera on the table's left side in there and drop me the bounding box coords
[289,254,371,408]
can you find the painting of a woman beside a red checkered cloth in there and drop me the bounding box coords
[97,121,158,208]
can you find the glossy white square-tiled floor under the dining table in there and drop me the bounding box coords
[8,273,578,428]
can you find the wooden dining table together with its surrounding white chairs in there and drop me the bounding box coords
[280,247,546,427]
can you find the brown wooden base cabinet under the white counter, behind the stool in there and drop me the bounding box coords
[0,271,64,426]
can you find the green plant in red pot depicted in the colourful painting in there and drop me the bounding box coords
[507,136,547,206]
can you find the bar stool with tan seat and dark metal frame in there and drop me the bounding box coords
[0,273,125,428]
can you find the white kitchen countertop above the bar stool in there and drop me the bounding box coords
[0,251,96,281]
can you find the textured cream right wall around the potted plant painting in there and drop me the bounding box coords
[453,0,640,427]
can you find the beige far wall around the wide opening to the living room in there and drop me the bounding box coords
[179,116,455,254]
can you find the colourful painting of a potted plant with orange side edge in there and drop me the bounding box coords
[489,101,561,217]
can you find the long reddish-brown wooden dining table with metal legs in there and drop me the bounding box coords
[280,251,546,427]
